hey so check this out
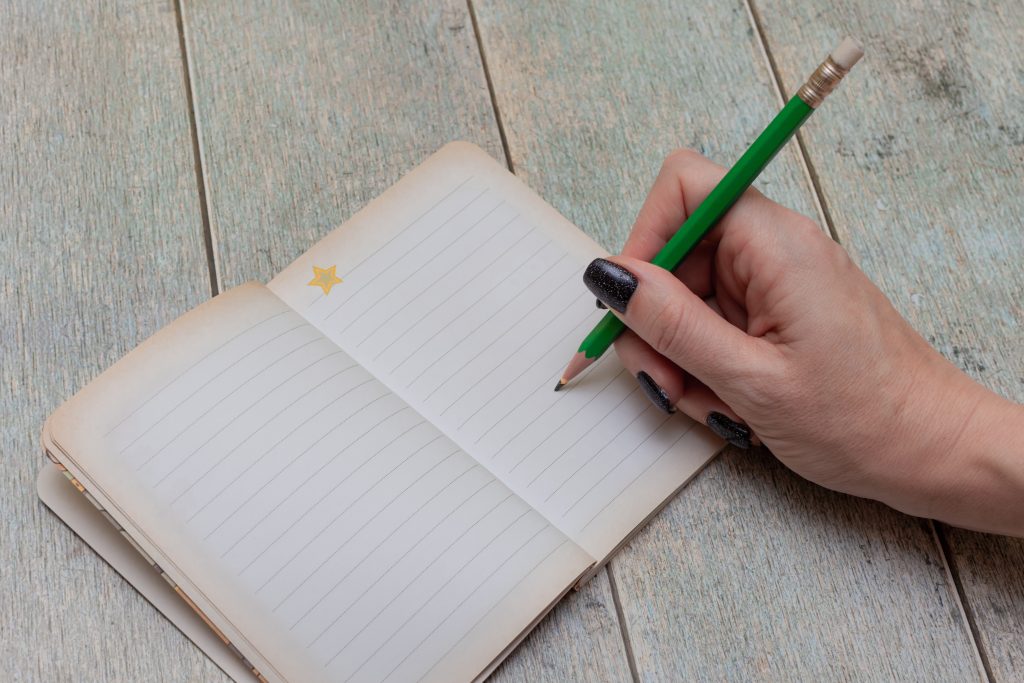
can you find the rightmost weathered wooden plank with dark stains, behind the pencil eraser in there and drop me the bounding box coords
[756,0,1024,681]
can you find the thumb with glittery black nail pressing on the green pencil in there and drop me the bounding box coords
[583,256,764,391]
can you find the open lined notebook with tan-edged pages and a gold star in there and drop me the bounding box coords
[43,143,722,682]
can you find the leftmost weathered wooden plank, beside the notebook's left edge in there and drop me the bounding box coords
[0,0,225,681]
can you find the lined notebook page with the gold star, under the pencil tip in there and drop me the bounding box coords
[270,144,720,558]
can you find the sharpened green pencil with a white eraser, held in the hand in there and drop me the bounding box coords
[555,38,864,391]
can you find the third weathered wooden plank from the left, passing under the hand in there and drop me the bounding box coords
[474,0,982,680]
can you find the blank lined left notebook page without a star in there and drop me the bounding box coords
[52,286,593,681]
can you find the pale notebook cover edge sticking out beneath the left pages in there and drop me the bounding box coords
[36,464,257,683]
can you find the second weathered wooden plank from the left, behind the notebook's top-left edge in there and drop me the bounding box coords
[178,0,629,680]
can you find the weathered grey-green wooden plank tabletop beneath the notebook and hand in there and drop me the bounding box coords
[0,0,1024,681]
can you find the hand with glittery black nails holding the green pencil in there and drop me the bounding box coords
[584,152,1024,535]
